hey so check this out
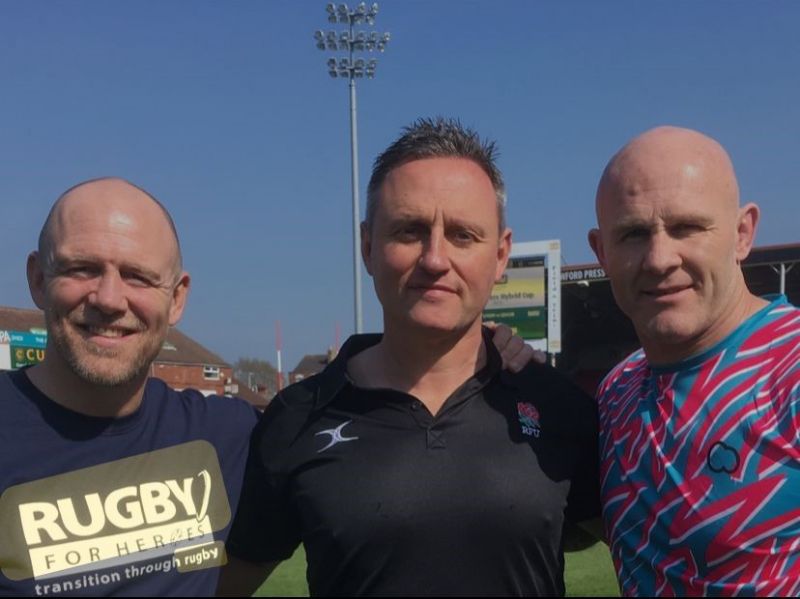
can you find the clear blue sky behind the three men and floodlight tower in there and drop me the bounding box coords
[0,0,800,370]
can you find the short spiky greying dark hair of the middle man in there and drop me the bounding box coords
[364,117,506,231]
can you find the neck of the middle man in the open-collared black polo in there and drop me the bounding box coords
[348,321,486,415]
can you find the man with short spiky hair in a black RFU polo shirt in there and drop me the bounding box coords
[221,119,598,595]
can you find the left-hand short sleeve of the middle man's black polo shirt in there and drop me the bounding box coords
[227,395,300,563]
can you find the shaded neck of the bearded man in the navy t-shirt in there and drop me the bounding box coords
[26,352,147,418]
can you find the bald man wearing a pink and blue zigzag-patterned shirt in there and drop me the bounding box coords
[589,127,800,596]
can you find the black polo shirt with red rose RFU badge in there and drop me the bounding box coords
[229,335,599,595]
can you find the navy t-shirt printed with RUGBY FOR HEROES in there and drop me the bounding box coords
[0,371,258,597]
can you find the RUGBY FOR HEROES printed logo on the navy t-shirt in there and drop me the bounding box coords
[0,441,231,581]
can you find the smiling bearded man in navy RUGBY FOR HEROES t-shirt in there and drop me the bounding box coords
[0,178,257,596]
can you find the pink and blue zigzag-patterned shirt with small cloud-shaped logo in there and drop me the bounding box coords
[598,297,800,596]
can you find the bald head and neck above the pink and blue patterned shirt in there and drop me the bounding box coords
[589,127,761,363]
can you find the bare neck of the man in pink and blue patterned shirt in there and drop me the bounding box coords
[640,282,769,366]
